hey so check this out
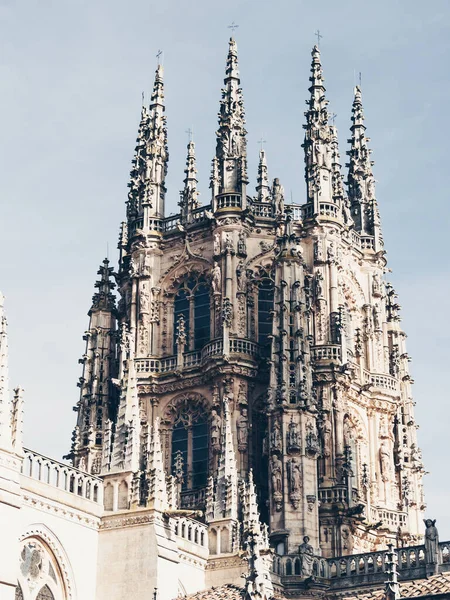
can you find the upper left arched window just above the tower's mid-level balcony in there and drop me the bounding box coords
[173,276,211,353]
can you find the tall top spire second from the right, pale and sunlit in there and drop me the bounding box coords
[303,46,332,217]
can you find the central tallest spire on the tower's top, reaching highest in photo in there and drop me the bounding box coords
[211,38,248,210]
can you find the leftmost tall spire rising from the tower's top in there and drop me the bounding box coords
[127,65,169,233]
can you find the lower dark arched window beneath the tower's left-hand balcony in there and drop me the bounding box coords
[171,408,208,492]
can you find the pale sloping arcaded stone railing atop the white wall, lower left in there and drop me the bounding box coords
[22,449,103,505]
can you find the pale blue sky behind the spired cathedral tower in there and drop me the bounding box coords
[0,0,450,539]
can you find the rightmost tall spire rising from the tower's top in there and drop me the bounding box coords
[347,86,383,250]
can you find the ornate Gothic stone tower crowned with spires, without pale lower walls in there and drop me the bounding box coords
[71,39,424,560]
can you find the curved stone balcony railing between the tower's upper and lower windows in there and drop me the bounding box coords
[135,338,260,374]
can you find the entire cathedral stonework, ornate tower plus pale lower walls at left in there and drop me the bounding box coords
[0,39,447,600]
